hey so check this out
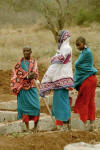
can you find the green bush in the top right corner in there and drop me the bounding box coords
[76,0,100,25]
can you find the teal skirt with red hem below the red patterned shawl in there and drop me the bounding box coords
[17,88,40,122]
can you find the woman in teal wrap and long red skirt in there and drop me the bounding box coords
[74,37,97,131]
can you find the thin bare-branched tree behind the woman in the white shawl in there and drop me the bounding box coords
[41,0,72,42]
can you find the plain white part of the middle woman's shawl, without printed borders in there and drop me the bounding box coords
[41,39,73,83]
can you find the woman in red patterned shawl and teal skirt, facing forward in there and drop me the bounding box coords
[11,46,40,131]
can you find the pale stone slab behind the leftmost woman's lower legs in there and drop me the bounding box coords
[0,113,55,135]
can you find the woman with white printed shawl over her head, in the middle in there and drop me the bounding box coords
[40,30,73,129]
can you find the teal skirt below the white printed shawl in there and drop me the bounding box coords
[52,89,71,121]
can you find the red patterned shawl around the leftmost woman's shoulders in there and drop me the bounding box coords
[11,58,38,95]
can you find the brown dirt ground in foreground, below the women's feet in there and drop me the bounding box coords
[0,131,100,150]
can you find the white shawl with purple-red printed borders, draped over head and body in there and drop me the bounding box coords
[40,31,74,96]
